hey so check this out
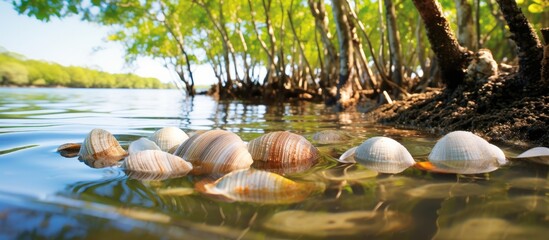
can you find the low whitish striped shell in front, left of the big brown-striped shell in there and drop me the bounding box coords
[122,150,193,180]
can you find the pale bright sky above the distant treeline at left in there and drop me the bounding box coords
[0,1,214,84]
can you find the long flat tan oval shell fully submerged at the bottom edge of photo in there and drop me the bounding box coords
[263,210,412,238]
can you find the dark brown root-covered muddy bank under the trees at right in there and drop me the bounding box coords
[368,72,549,148]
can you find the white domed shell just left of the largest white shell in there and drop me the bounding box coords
[354,137,415,173]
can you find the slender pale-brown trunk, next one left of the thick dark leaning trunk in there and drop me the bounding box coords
[382,0,403,98]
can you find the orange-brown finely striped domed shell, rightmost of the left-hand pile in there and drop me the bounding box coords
[248,131,320,171]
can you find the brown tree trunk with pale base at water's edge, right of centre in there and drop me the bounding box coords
[332,0,354,109]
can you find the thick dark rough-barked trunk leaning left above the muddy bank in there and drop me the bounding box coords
[413,0,472,89]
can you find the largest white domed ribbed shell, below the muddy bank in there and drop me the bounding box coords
[428,131,505,174]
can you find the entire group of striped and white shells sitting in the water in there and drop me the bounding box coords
[58,127,549,203]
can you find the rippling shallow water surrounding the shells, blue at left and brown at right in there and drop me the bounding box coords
[0,88,549,239]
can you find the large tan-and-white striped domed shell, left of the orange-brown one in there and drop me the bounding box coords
[174,130,253,174]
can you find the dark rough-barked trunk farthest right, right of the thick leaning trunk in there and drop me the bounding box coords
[497,0,543,85]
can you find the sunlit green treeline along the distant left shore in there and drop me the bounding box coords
[0,52,166,88]
